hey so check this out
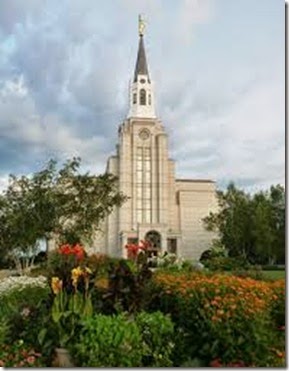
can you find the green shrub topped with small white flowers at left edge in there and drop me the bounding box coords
[0,276,55,360]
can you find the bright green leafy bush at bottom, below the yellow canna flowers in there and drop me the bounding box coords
[71,314,142,367]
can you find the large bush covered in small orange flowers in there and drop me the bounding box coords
[153,273,284,366]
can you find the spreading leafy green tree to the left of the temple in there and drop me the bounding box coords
[0,158,126,265]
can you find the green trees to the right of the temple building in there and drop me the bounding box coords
[204,184,285,264]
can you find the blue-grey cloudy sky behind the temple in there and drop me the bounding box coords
[0,0,285,195]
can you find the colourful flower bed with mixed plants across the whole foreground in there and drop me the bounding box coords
[0,245,285,367]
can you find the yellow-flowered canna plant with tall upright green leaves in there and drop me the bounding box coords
[51,266,93,347]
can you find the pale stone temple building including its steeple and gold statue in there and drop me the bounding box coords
[91,19,217,259]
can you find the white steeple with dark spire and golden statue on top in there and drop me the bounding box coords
[128,16,156,118]
